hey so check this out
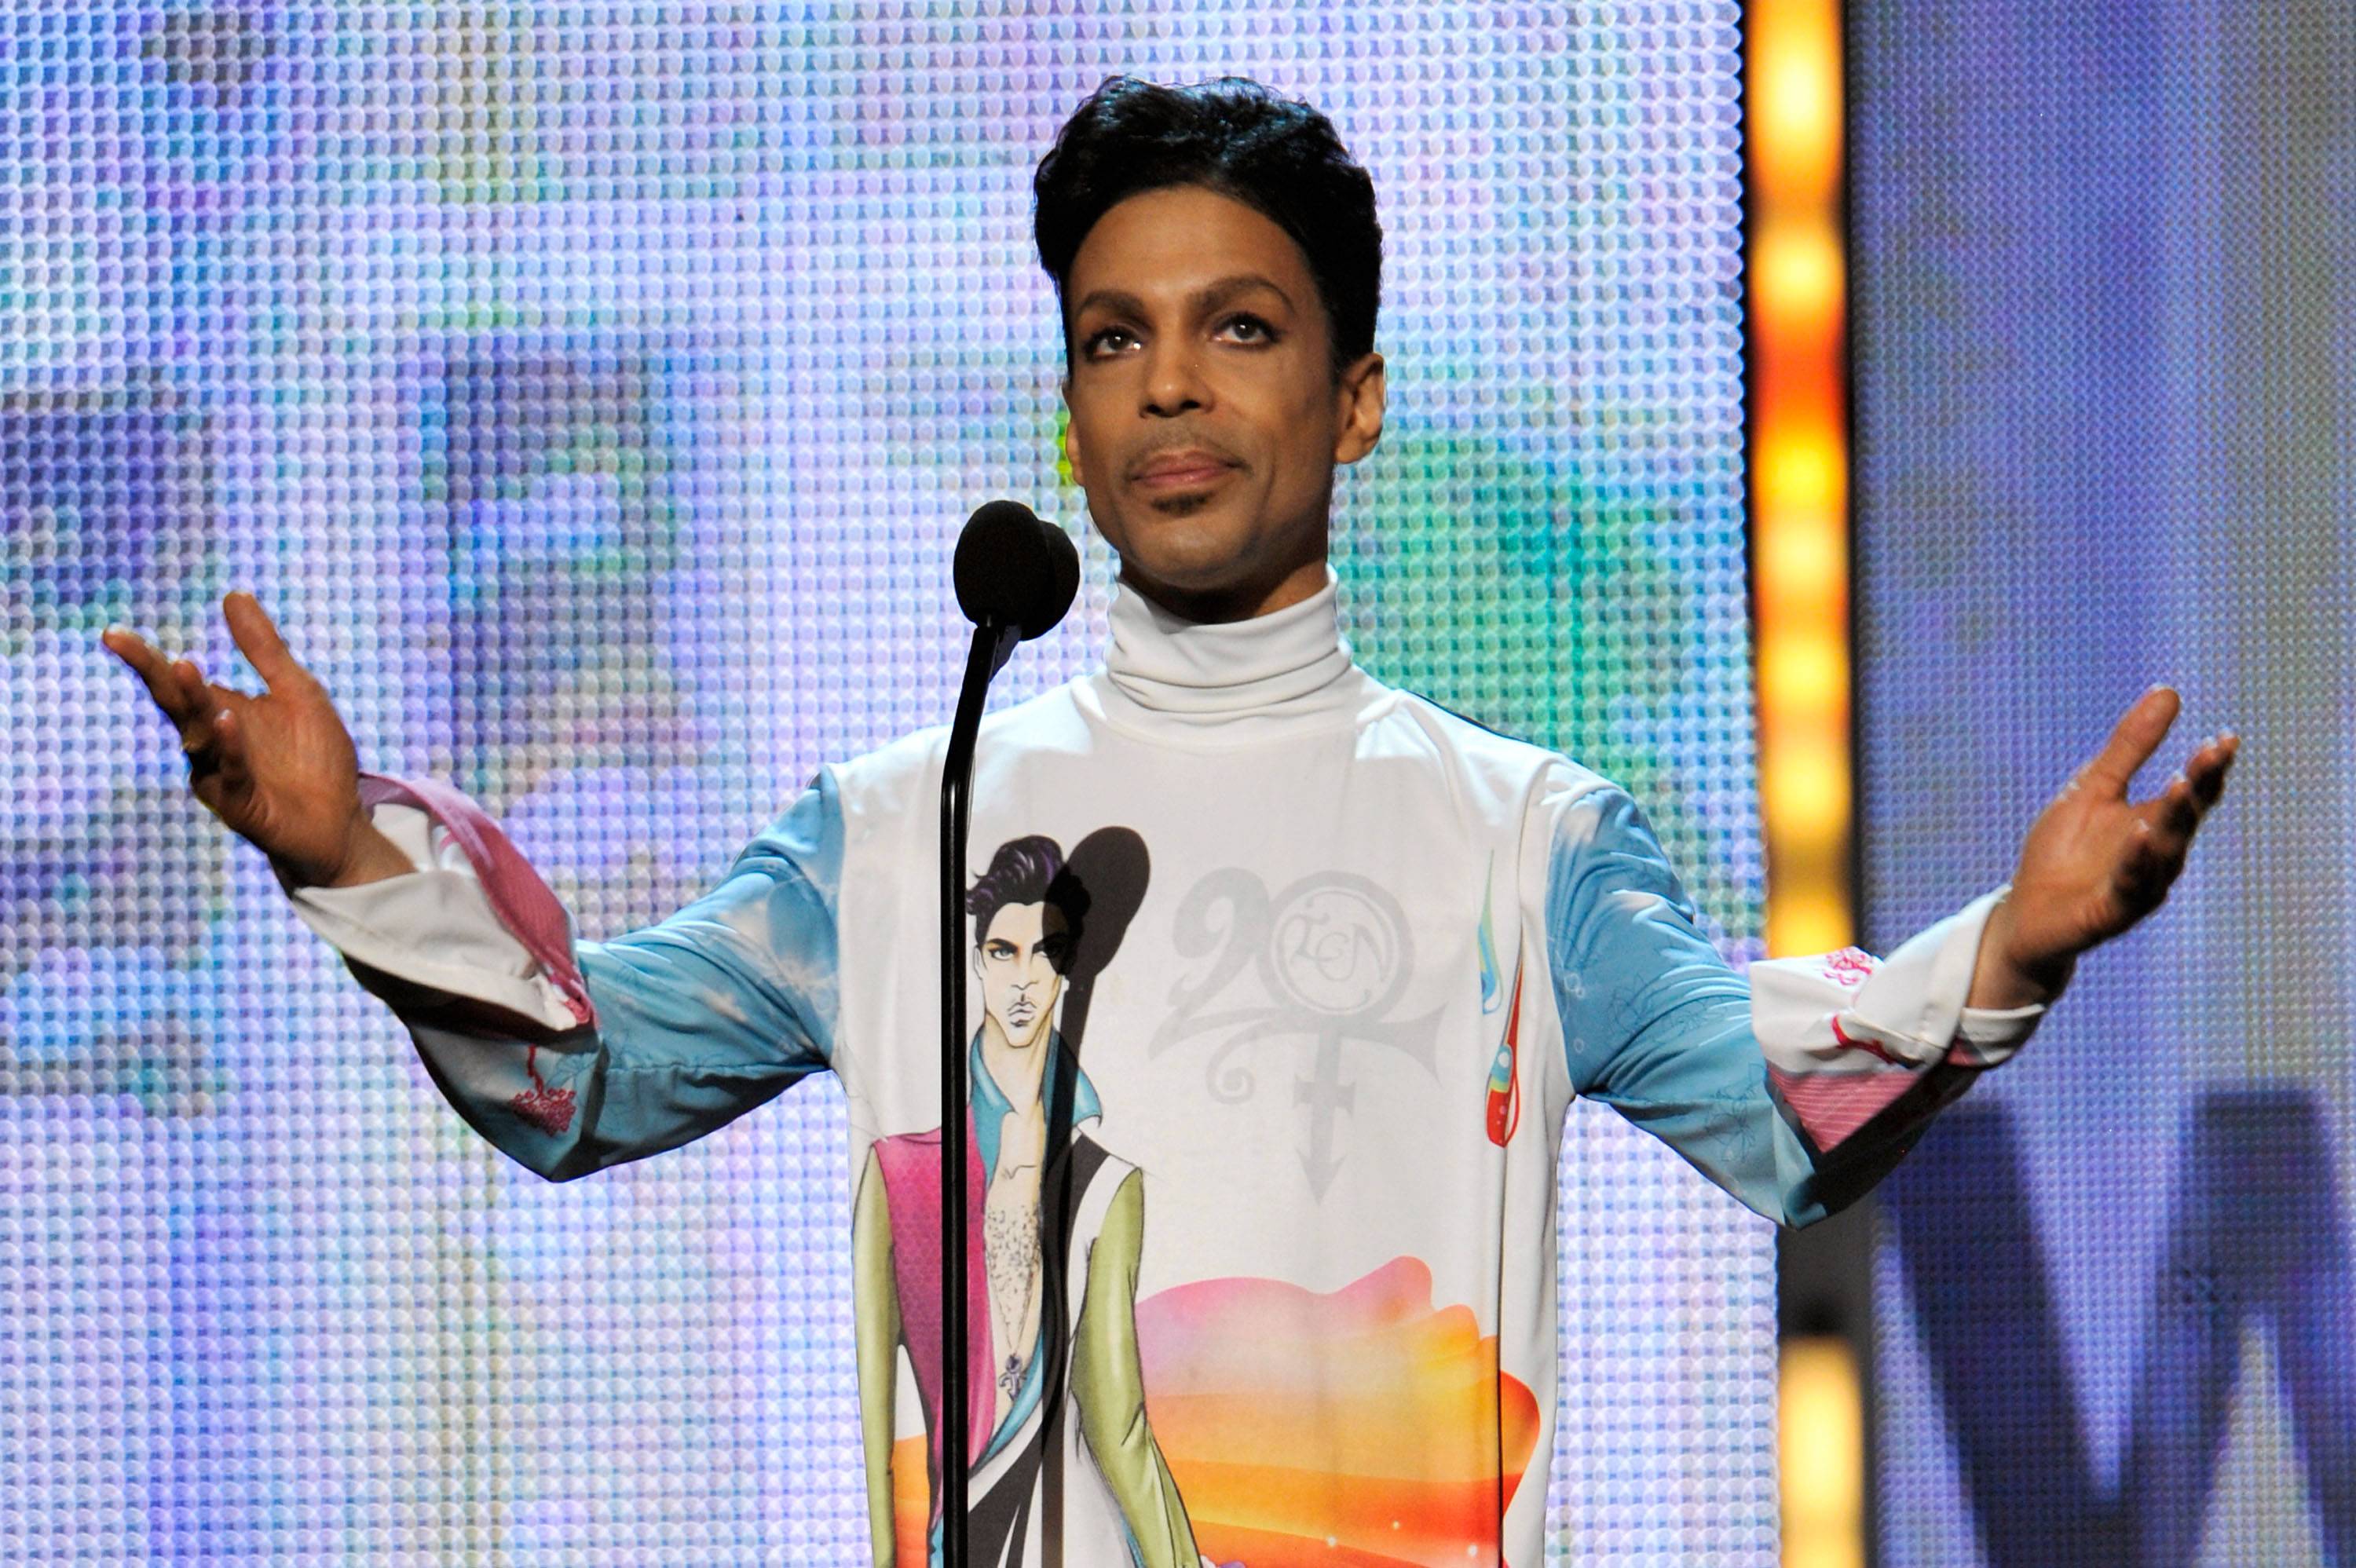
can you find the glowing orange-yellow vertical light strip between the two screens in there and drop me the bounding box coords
[1743,0,1866,1568]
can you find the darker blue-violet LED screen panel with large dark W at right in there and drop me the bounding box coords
[1849,0,2356,1568]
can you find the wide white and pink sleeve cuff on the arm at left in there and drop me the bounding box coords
[280,773,596,1031]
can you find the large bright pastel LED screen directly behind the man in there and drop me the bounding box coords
[0,0,1774,1563]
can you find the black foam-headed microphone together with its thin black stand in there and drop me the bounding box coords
[933,502,1079,1568]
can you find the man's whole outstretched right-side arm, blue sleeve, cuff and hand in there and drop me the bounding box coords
[1546,693,2233,1224]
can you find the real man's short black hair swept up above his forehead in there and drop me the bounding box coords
[1032,75,1383,382]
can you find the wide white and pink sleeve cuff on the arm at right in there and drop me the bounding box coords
[1751,885,2045,1149]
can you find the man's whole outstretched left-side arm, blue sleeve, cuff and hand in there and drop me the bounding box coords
[104,591,841,1177]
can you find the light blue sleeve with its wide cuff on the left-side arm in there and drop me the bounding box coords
[304,770,843,1182]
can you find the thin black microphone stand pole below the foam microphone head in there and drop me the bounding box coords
[933,620,1023,1568]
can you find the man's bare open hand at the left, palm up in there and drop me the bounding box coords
[99,589,415,887]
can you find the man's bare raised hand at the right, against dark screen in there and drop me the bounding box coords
[1970,685,2241,1007]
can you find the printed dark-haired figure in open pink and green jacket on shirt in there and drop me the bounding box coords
[853,828,1202,1568]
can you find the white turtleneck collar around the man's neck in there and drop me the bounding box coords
[1093,568,1385,742]
